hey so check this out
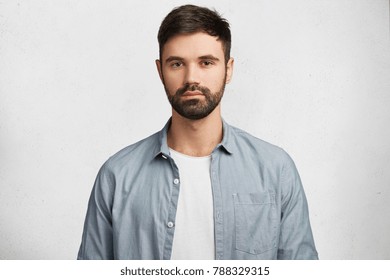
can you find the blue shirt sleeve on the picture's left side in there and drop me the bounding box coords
[77,163,114,260]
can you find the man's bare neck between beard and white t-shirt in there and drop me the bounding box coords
[168,106,223,157]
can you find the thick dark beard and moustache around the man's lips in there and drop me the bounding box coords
[164,76,226,120]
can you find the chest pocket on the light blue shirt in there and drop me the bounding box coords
[233,192,278,254]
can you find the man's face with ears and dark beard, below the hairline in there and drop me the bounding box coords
[156,32,233,120]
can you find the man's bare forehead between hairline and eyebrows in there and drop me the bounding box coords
[162,32,224,59]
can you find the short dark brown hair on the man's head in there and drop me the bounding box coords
[157,5,231,63]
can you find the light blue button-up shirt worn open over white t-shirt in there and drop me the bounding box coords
[78,118,318,260]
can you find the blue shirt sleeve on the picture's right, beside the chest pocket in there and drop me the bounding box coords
[278,152,318,260]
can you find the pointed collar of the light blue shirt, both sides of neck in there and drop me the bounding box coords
[154,118,235,157]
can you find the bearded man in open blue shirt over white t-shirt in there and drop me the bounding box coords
[78,5,317,259]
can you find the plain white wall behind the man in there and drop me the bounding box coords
[0,0,390,259]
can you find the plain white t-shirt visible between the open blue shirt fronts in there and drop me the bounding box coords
[170,149,215,260]
